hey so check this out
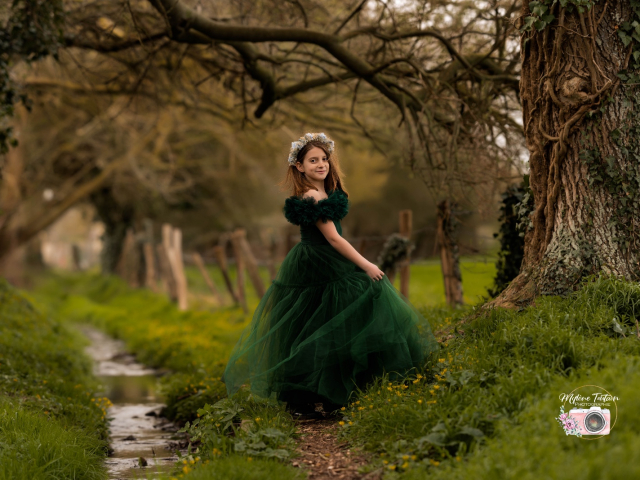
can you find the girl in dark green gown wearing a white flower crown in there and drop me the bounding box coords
[223,133,438,418]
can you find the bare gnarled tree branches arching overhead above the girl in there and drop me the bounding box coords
[60,0,522,197]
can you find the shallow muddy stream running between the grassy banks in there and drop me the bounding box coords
[81,326,178,480]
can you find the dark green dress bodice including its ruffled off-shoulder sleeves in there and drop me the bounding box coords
[283,189,349,245]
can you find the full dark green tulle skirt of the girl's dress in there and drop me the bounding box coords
[223,243,439,405]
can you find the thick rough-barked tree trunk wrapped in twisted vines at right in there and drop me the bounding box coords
[493,0,640,306]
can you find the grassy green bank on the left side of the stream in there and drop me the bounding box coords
[0,279,108,480]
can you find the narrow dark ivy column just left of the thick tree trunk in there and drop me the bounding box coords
[488,175,533,297]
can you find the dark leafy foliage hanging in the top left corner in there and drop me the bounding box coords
[0,0,63,154]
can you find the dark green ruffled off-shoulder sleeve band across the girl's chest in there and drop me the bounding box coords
[282,190,349,225]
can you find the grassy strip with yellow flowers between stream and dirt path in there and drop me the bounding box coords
[27,275,297,478]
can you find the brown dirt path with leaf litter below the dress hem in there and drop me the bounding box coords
[292,419,381,480]
